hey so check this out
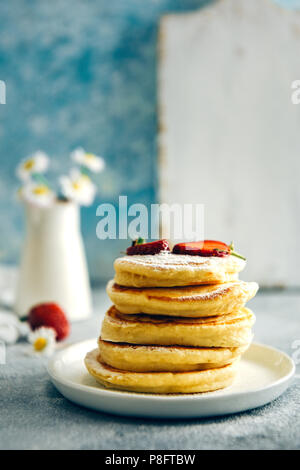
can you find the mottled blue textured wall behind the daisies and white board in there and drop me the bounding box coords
[0,0,295,280]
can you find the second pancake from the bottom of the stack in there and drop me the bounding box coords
[98,338,249,372]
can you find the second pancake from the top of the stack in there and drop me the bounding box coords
[106,281,258,317]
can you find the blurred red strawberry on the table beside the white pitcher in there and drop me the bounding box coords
[28,303,70,341]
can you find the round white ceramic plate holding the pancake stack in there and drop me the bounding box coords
[48,339,295,418]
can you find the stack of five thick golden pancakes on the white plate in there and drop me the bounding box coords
[85,252,258,393]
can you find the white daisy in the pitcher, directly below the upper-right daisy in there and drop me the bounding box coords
[59,168,97,206]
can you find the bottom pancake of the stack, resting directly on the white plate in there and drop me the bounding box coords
[85,349,237,393]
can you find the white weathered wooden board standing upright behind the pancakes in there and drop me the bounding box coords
[159,0,300,286]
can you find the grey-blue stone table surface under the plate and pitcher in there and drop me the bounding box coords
[0,289,300,450]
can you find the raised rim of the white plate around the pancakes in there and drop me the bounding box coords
[47,338,296,401]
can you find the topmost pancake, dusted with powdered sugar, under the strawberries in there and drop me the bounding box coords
[114,252,246,287]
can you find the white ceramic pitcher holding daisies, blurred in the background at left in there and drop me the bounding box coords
[15,200,91,321]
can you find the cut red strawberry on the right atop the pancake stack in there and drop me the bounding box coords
[172,240,246,260]
